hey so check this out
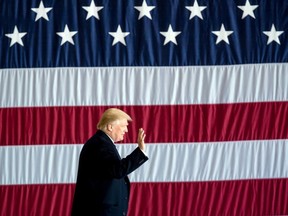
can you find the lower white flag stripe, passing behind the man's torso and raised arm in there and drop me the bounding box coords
[0,140,288,184]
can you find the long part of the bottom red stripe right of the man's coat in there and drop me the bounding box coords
[129,179,288,216]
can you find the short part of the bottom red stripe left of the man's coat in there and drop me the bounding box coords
[0,184,75,216]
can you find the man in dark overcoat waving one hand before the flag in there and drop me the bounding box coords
[72,108,148,216]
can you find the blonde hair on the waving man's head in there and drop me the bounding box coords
[97,108,132,130]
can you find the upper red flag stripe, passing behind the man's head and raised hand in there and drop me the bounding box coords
[0,102,288,145]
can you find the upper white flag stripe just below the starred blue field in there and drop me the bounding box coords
[0,63,288,107]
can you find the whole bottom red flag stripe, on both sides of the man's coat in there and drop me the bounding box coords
[0,179,288,216]
